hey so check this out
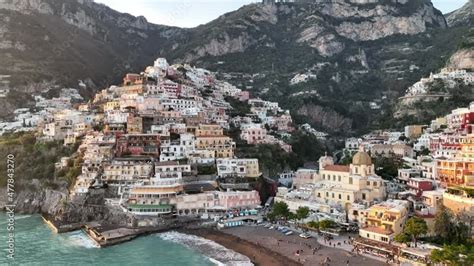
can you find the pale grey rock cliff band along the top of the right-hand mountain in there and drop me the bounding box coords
[175,0,446,61]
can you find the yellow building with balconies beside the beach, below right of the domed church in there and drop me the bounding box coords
[359,200,410,243]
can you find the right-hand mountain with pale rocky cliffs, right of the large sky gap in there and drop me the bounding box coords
[170,0,463,134]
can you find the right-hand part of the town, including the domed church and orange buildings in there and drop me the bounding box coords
[275,99,474,265]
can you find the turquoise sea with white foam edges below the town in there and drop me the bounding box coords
[0,213,251,266]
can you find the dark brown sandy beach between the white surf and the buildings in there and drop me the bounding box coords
[187,226,386,266]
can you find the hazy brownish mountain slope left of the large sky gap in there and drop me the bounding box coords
[0,0,184,118]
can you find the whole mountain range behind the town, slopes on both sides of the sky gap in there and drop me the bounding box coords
[0,0,472,134]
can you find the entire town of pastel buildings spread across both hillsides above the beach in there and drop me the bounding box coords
[2,58,474,265]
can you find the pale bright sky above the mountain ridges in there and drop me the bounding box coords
[95,0,468,28]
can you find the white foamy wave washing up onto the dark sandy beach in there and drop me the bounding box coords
[158,231,253,266]
